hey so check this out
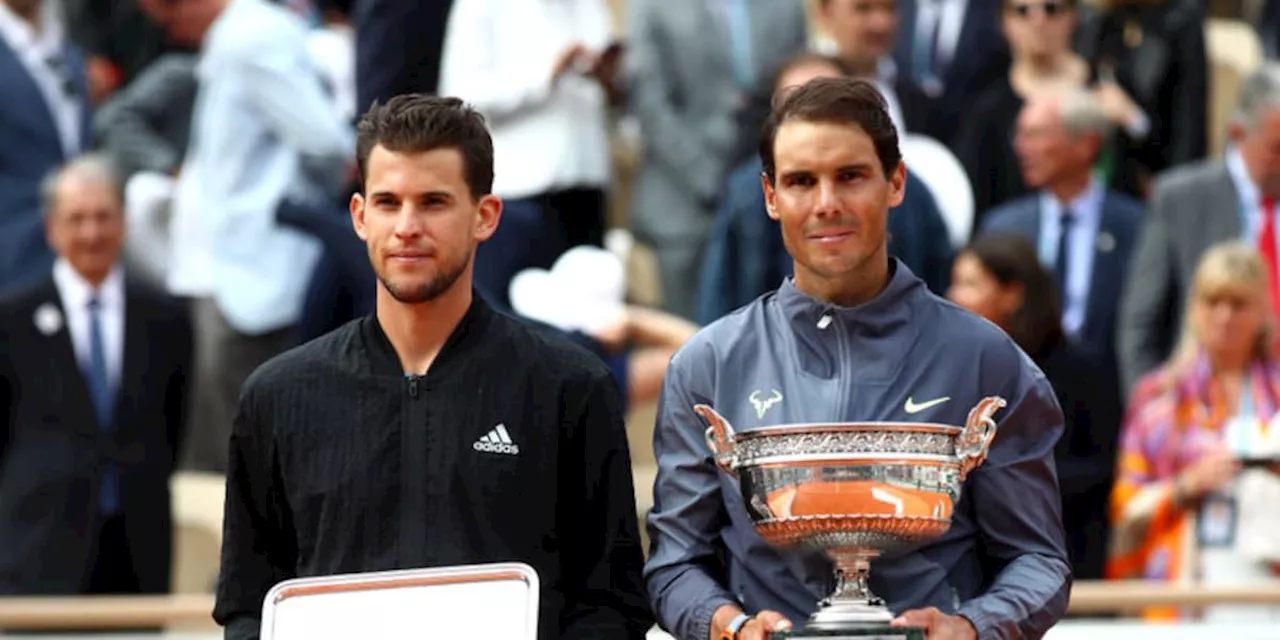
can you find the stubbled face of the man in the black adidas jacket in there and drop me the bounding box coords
[351,145,502,305]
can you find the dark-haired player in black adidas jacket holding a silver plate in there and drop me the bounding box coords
[214,95,653,640]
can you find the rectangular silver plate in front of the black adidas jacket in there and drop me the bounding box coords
[261,562,539,640]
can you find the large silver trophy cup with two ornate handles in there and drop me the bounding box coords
[694,397,1005,637]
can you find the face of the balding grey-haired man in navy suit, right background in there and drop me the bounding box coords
[1014,100,1094,189]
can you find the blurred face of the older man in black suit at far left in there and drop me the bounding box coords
[45,175,124,282]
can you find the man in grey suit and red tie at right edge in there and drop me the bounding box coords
[1119,63,1280,389]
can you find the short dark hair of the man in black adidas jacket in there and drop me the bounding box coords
[356,93,493,198]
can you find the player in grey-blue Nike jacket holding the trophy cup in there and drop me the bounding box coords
[645,78,1070,640]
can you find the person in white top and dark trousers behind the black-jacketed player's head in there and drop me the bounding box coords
[440,0,621,306]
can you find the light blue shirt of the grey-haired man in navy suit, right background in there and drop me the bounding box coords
[1039,178,1115,335]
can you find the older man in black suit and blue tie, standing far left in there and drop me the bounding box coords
[0,156,192,595]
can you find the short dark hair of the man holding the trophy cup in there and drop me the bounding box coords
[760,77,902,182]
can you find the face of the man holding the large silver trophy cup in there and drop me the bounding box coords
[763,120,906,280]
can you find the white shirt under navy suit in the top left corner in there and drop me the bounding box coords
[0,3,84,157]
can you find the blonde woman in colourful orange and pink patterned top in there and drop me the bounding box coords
[1107,242,1280,622]
